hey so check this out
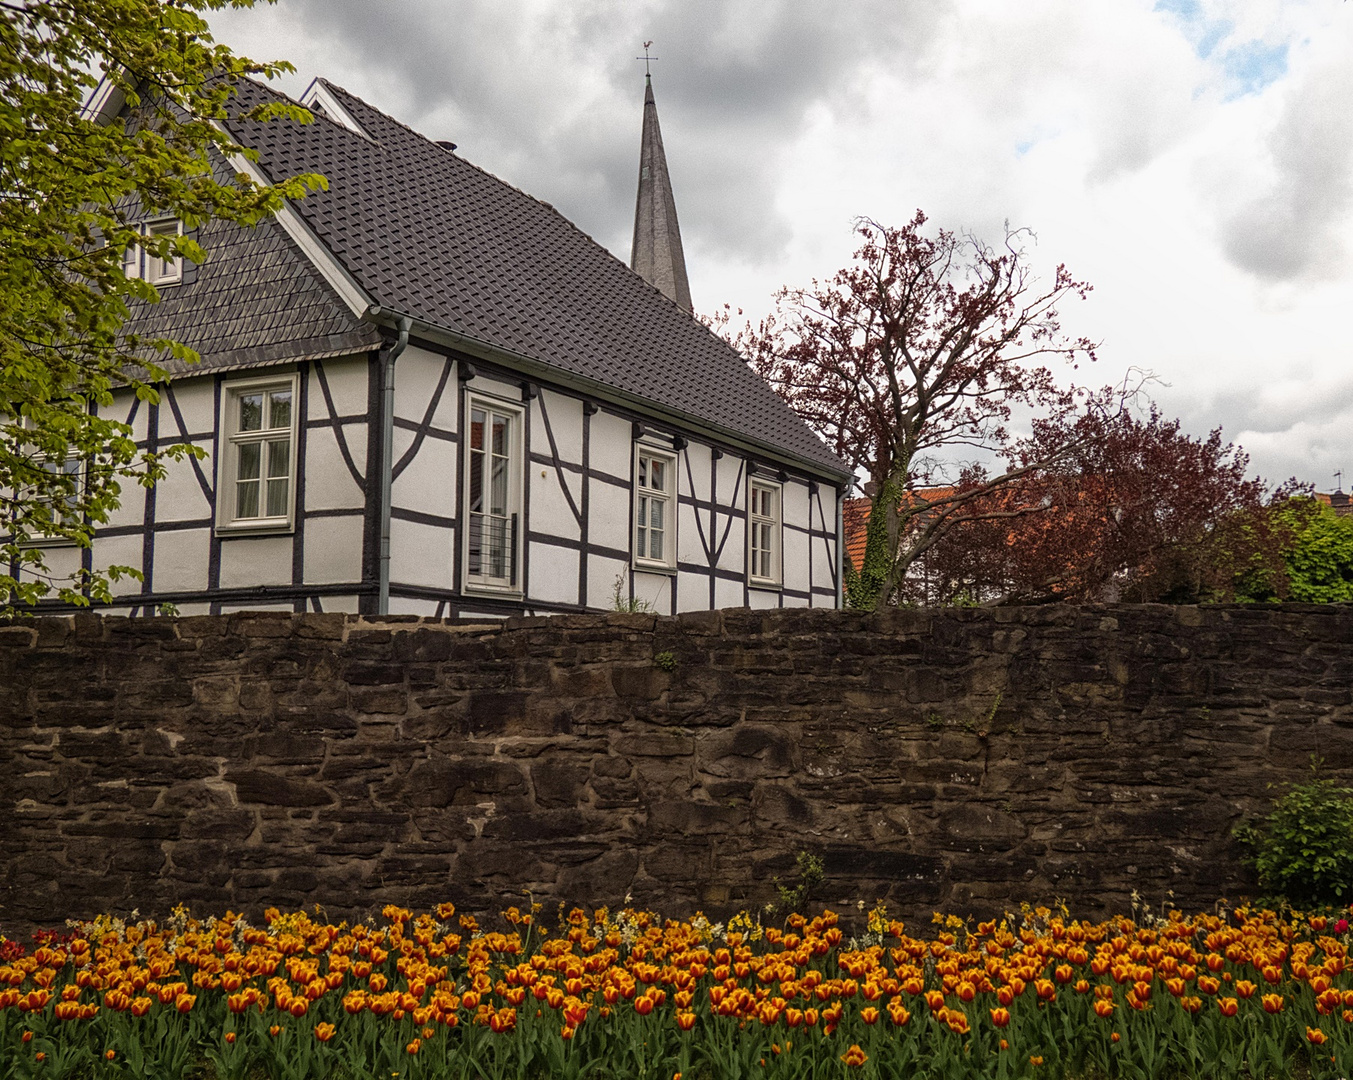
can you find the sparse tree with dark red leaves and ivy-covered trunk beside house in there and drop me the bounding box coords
[735,211,1095,606]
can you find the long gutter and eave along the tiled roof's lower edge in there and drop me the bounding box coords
[367,305,851,485]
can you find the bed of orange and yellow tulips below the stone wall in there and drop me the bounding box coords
[0,904,1353,1080]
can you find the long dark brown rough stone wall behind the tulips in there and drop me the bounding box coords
[0,605,1353,932]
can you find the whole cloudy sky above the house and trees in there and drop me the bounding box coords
[214,0,1353,490]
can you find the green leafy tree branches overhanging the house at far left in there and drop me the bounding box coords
[0,0,323,609]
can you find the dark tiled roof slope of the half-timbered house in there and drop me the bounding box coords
[231,83,848,475]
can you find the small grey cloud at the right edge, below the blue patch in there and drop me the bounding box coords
[1222,51,1353,280]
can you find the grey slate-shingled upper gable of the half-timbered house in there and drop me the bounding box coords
[127,205,380,375]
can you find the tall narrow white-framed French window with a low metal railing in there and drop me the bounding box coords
[464,395,525,593]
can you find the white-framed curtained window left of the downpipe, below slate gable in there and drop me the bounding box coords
[216,372,298,531]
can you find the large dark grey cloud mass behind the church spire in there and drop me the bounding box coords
[216,0,948,282]
